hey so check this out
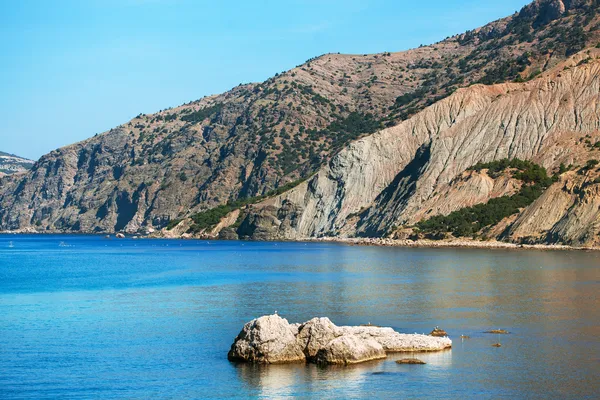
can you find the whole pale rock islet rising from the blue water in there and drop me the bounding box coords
[227,314,452,365]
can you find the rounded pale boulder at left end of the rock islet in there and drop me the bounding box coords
[227,315,306,364]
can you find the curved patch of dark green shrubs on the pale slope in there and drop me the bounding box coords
[417,159,554,237]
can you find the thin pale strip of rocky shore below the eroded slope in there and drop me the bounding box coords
[309,237,600,251]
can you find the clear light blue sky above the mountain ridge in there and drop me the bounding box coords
[0,0,529,159]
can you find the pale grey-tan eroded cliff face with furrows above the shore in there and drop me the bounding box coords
[240,49,600,244]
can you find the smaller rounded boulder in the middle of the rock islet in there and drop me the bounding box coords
[316,334,386,364]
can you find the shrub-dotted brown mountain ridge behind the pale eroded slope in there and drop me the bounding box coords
[0,0,600,245]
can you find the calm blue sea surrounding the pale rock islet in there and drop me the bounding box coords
[0,235,600,399]
